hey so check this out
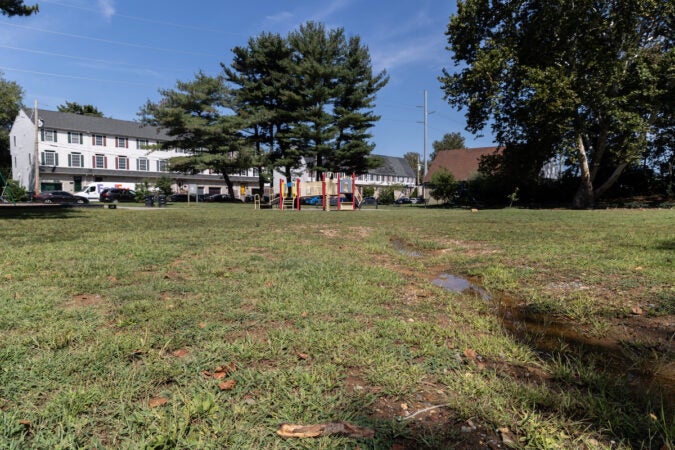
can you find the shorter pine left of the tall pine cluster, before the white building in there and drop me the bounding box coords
[139,72,251,197]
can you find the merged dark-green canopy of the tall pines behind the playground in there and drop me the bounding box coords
[222,22,388,183]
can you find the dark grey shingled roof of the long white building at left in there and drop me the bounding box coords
[33,109,172,141]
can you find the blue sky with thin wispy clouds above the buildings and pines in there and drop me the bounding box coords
[0,0,493,160]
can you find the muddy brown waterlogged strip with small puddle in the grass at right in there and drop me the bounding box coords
[432,273,675,404]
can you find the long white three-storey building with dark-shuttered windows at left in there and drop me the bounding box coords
[10,110,258,195]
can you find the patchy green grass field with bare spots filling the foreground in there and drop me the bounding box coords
[0,204,675,450]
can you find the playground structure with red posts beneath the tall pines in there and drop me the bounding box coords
[254,173,363,211]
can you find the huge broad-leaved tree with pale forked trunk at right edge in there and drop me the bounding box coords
[440,0,675,208]
